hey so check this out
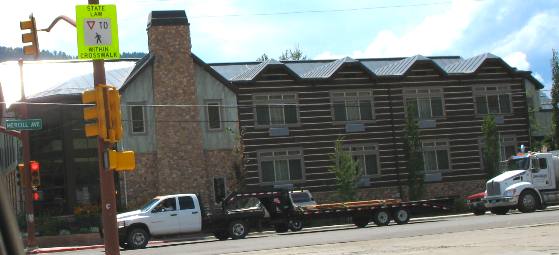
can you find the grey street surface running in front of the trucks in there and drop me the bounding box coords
[60,209,559,255]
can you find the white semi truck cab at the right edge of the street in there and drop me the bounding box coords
[484,151,559,214]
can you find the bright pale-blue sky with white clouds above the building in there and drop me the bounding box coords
[0,0,559,94]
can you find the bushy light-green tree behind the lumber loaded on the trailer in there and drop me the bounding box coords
[329,137,361,201]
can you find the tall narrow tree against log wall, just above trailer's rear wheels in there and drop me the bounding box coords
[404,104,425,200]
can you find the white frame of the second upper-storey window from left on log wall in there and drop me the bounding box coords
[330,89,375,124]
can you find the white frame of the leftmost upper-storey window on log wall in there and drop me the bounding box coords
[252,93,301,128]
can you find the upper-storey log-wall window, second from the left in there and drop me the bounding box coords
[331,91,374,122]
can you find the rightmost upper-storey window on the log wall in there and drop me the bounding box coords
[474,86,512,114]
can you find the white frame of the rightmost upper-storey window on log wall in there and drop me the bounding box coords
[473,85,514,116]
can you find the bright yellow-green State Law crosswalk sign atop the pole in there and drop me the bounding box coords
[76,4,120,59]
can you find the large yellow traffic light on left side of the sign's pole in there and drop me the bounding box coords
[82,86,107,139]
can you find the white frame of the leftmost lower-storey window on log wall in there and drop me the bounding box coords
[257,148,305,185]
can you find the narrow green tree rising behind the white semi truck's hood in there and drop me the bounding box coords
[481,115,500,179]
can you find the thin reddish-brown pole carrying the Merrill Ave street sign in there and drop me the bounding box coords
[18,59,37,250]
